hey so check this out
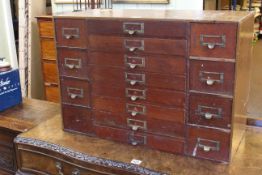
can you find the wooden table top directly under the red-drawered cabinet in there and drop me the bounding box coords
[17,115,262,175]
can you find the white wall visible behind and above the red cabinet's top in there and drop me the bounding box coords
[52,0,203,13]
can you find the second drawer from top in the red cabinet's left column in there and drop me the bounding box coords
[58,48,88,79]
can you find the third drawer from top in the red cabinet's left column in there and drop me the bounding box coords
[61,77,90,107]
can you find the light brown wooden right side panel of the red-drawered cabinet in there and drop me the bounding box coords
[231,15,254,158]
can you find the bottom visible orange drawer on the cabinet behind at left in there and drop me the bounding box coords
[45,82,60,103]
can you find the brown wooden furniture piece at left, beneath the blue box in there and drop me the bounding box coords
[0,99,60,174]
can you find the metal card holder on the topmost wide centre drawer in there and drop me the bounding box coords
[123,22,145,35]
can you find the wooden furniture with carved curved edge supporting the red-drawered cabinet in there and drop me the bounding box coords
[15,115,262,175]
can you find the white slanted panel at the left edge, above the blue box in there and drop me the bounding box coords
[0,0,18,68]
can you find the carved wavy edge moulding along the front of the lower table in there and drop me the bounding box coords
[14,136,167,175]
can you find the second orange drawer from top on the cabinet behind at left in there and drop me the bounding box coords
[41,38,56,60]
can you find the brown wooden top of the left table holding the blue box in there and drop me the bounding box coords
[0,98,60,133]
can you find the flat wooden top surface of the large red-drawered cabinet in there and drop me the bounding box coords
[54,9,253,22]
